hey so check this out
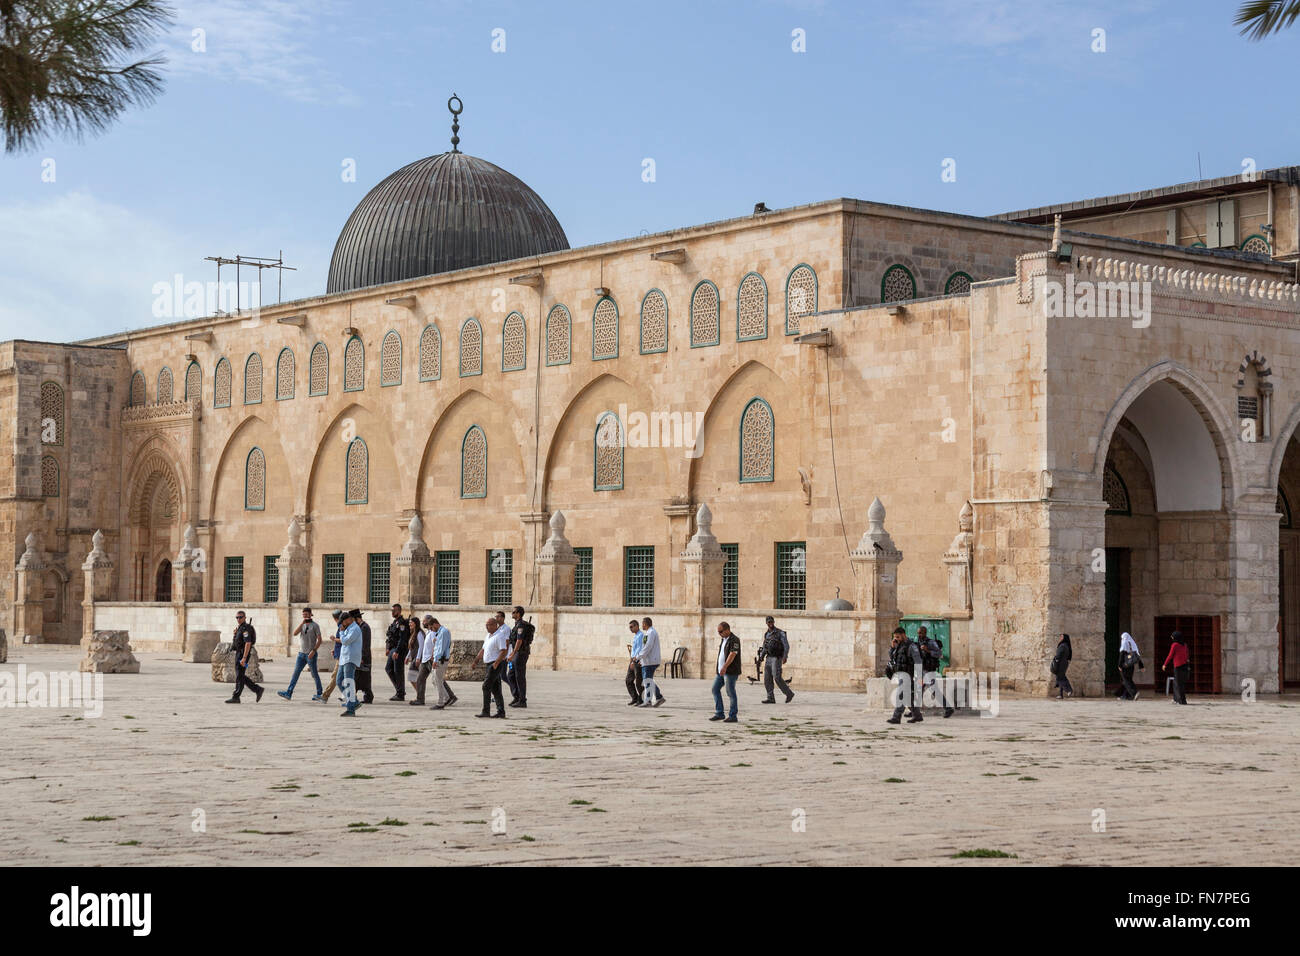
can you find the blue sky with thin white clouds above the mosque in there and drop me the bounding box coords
[0,0,1300,341]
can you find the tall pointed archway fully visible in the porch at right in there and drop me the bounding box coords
[1096,368,1236,693]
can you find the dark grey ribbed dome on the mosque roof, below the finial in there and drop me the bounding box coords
[325,152,569,293]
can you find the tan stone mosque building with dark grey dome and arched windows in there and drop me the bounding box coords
[0,106,1300,695]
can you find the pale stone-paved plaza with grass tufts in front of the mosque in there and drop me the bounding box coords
[0,646,1300,865]
